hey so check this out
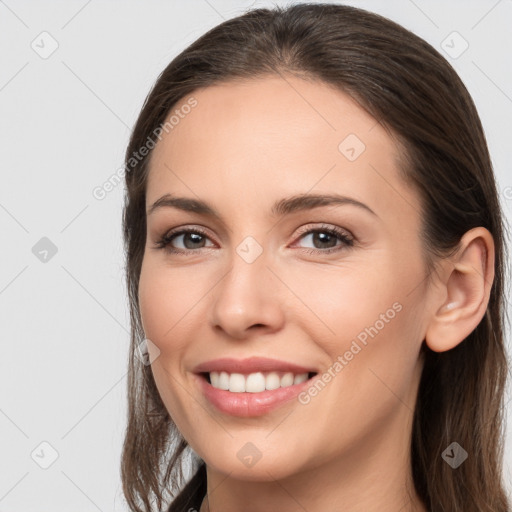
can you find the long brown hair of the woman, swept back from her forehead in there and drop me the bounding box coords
[121,3,509,512]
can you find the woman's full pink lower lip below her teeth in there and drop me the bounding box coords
[195,374,316,418]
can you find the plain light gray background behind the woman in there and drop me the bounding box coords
[0,0,512,512]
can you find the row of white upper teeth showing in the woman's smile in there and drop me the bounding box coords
[206,372,308,393]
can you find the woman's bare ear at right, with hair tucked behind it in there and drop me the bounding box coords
[425,227,494,352]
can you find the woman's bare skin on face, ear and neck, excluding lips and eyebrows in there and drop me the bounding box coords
[139,76,494,512]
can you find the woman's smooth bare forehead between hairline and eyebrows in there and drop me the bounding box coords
[147,75,415,224]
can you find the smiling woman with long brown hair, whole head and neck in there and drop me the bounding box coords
[122,4,509,512]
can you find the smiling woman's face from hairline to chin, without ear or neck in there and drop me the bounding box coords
[139,77,432,480]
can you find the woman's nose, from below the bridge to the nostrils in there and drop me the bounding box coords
[211,247,285,340]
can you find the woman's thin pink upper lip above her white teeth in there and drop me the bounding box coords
[194,357,316,374]
